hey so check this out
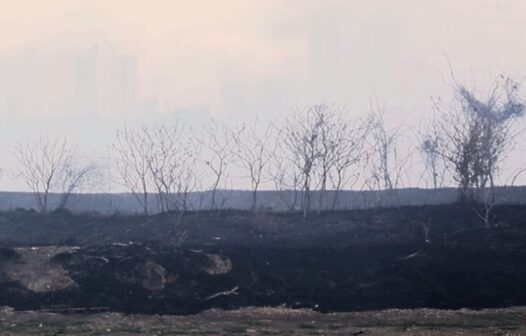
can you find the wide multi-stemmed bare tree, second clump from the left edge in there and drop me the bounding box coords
[113,122,197,214]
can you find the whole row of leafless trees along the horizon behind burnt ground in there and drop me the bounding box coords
[9,77,526,218]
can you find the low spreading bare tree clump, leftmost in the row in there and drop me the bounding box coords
[15,138,97,213]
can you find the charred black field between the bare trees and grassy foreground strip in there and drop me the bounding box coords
[0,205,526,314]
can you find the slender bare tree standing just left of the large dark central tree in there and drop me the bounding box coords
[232,119,277,210]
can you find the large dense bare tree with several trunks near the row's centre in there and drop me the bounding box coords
[273,104,365,217]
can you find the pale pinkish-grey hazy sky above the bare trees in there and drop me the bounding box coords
[0,0,526,189]
